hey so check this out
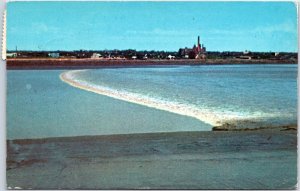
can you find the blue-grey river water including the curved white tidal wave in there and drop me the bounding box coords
[7,64,297,139]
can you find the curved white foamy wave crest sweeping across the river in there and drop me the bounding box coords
[60,70,276,126]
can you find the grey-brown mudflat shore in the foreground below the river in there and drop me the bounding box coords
[7,129,297,189]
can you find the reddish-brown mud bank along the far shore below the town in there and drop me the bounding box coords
[7,58,298,70]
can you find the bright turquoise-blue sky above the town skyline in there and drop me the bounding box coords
[7,2,298,52]
